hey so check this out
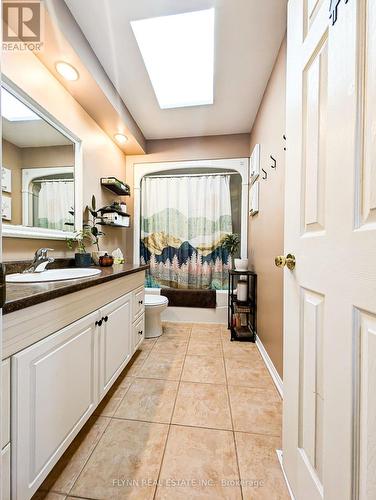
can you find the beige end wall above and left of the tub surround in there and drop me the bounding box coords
[127,134,249,256]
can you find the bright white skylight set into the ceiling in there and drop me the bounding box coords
[131,9,214,109]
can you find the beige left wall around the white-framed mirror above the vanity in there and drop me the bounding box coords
[2,52,129,261]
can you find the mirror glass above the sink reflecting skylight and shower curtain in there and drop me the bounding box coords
[1,88,75,231]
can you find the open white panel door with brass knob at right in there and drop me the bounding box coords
[283,0,376,500]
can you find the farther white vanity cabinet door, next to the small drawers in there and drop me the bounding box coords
[100,294,131,397]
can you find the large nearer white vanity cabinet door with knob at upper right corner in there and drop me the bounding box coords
[11,312,98,500]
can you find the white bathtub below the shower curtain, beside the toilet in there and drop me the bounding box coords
[145,288,228,324]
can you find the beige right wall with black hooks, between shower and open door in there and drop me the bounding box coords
[248,37,286,377]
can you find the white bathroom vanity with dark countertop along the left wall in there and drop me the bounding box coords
[1,265,146,500]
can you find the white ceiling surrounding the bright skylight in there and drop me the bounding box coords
[65,0,287,139]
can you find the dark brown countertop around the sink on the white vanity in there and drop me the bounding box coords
[3,264,149,314]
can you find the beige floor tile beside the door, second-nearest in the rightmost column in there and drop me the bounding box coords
[228,386,282,436]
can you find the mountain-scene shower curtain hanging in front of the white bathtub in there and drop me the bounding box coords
[140,175,232,289]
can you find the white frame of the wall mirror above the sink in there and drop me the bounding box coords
[1,75,83,240]
